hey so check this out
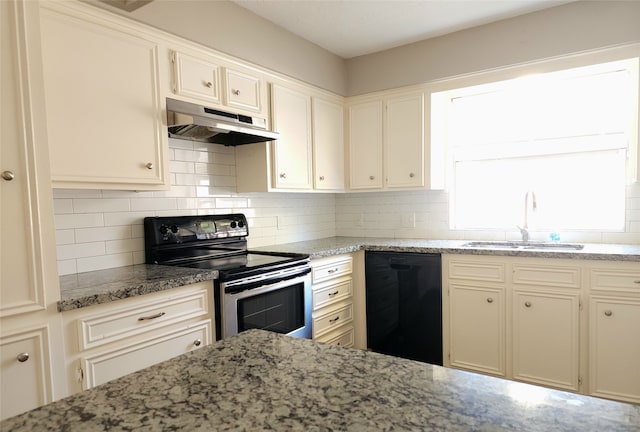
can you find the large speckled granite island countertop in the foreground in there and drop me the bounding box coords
[0,330,640,432]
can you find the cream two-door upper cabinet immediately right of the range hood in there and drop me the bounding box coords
[236,81,344,192]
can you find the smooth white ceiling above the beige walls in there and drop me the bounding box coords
[232,0,575,58]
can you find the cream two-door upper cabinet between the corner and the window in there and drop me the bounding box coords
[348,90,426,190]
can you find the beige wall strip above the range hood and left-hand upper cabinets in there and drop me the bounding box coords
[87,0,347,95]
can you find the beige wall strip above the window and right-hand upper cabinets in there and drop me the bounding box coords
[347,1,640,96]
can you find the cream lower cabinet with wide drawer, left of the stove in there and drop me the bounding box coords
[63,282,214,392]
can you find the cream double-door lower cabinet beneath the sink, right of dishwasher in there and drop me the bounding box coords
[443,255,581,391]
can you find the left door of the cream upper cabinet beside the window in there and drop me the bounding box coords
[349,101,382,189]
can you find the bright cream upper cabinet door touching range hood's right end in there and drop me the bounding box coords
[271,84,312,189]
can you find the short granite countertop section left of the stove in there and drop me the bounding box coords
[58,264,218,312]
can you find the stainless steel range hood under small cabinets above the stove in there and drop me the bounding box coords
[167,98,278,146]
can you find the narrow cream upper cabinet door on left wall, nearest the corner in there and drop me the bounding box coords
[312,98,344,190]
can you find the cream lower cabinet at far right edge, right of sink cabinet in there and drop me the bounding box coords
[589,263,640,403]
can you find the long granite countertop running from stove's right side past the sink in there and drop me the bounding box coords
[253,237,640,262]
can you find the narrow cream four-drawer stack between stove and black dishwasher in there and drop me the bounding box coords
[311,255,355,347]
